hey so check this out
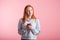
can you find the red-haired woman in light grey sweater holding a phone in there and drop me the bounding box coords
[18,5,40,40]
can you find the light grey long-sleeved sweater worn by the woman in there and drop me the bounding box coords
[18,18,40,39]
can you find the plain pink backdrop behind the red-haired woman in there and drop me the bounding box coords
[0,0,60,40]
